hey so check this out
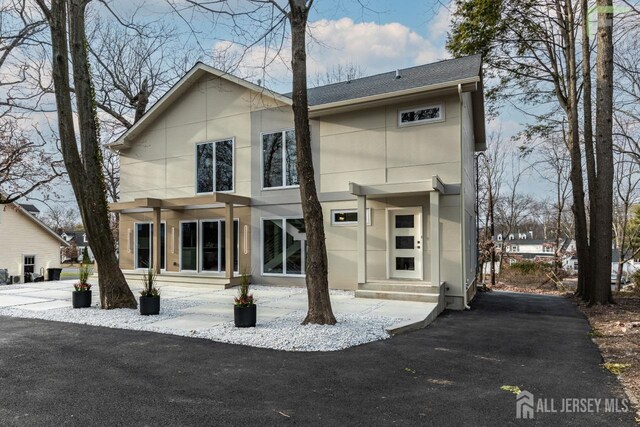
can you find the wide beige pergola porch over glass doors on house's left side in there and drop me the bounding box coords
[110,193,251,287]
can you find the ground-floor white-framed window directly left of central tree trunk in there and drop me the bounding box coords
[262,218,307,275]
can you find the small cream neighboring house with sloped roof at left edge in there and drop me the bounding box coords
[0,203,67,283]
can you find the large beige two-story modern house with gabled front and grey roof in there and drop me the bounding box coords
[111,56,486,309]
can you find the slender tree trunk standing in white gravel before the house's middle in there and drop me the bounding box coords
[289,0,336,325]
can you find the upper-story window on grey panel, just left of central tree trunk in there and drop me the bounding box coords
[262,130,299,188]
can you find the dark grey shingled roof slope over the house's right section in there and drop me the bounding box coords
[284,55,482,106]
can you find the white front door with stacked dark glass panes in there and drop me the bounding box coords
[389,207,422,280]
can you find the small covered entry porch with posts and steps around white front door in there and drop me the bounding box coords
[349,176,446,307]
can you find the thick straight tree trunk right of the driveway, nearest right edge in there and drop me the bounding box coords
[589,0,613,304]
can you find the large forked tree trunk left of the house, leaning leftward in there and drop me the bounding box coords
[45,0,137,309]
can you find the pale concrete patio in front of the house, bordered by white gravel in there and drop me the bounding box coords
[0,280,437,348]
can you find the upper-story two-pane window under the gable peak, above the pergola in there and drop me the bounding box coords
[196,139,233,193]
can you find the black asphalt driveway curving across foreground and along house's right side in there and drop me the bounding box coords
[0,292,634,426]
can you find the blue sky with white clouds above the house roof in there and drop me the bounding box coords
[22,0,546,214]
